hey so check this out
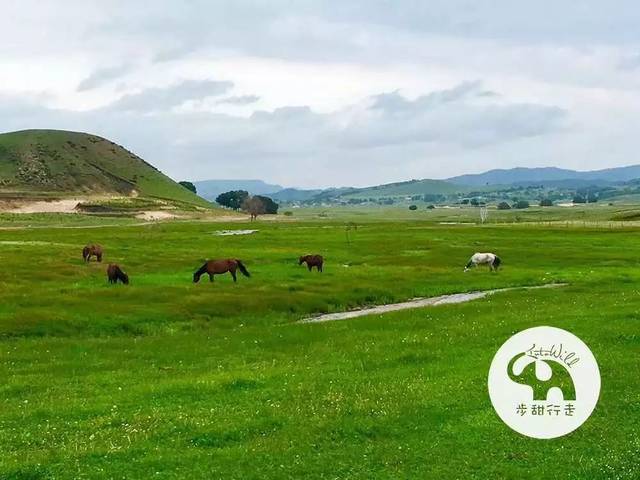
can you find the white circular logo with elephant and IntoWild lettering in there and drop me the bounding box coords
[488,327,600,438]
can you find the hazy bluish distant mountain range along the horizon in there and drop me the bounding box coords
[194,165,640,202]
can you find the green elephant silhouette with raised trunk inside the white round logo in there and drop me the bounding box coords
[507,352,576,401]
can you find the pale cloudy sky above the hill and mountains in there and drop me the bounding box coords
[0,0,640,187]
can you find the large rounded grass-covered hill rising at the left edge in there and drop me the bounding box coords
[0,130,210,207]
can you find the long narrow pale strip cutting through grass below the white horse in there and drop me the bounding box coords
[298,283,567,323]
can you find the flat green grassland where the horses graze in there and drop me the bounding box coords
[0,209,640,479]
